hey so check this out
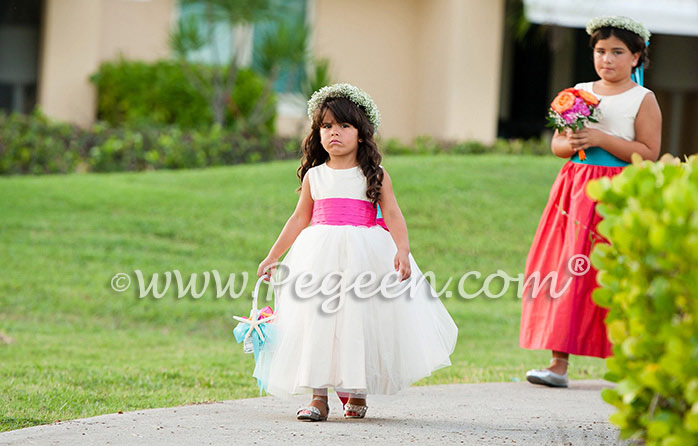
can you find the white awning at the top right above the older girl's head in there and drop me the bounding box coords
[524,0,698,36]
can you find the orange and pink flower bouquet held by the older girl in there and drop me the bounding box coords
[547,88,599,161]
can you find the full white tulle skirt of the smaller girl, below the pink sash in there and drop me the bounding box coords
[255,225,458,395]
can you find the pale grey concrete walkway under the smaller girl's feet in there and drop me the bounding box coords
[0,381,623,446]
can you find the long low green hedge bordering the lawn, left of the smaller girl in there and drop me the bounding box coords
[0,112,300,174]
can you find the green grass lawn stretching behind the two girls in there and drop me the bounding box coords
[0,155,605,431]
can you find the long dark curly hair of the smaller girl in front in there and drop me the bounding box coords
[296,97,383,206]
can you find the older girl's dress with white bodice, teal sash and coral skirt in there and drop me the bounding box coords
[520,82,649,358]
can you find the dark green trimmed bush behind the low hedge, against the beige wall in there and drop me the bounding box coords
[90,59,276,133]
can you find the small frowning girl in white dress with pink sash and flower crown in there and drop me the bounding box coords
[255,84,458,421]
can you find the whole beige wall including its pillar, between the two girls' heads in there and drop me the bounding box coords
[313,0,504,142]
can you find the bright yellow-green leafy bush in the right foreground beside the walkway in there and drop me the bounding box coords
[587,157,698,446]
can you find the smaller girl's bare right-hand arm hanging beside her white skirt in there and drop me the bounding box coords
[378,169,412,281]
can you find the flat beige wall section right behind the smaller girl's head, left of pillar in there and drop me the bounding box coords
[311,0,420,140]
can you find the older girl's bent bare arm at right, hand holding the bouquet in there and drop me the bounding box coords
[569,93,662,162]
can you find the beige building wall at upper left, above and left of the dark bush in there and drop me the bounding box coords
[38,0,175,126]
